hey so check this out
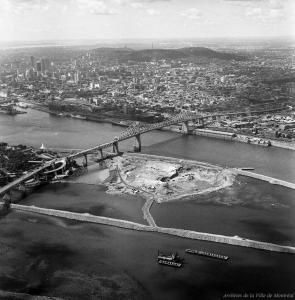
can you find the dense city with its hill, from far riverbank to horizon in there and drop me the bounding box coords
[0,47,295,140]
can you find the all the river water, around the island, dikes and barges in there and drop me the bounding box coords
[0,110,295,300]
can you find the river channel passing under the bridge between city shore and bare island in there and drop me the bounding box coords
[0,109,295,182]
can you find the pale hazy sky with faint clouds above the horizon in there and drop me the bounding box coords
[0,0,295,41]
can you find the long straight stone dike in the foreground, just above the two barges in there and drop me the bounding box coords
[11,204,295,254]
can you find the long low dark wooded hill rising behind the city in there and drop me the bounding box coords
[92,47,246,62]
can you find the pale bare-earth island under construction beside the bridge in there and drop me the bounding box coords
[107,154,235,203]
